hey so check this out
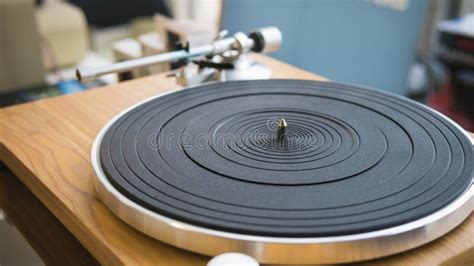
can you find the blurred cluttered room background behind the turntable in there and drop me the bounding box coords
[0,0,474,265]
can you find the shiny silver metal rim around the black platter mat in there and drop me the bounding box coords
[91,81,474,263]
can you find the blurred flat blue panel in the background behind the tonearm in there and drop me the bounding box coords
[222,0,426,94]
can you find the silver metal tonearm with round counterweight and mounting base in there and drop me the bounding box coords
[76,27,282,85]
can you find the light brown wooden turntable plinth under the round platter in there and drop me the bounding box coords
[0,55,474,265]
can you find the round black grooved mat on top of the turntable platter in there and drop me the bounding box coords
[99,80,473,237]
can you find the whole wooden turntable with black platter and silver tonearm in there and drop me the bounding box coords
[0,29,474,265]
